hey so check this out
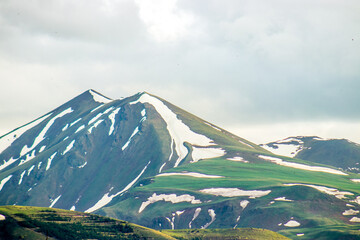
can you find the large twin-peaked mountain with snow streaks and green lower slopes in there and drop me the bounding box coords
[0,90,360,239]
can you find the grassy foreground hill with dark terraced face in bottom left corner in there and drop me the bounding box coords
[0,206,174,240]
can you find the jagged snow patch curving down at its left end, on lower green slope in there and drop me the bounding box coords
[139,193,201,213]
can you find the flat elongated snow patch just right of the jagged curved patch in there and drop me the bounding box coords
[200,188,271,198]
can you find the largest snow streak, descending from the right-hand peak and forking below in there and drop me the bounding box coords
[132,93,219,167]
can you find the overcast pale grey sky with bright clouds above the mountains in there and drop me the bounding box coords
[0,0,360,143]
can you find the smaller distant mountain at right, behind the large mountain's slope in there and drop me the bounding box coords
[260,136,360,173]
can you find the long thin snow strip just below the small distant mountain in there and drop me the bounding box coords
[258,155,348,175]
